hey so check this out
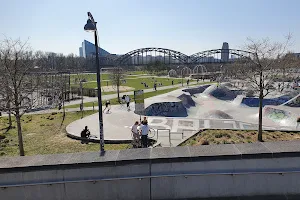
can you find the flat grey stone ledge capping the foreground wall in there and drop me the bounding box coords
[0,141,300,173]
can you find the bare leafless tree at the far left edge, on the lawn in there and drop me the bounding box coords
[0,39,34,156]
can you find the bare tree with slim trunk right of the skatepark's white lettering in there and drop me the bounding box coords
[236,35,291,141]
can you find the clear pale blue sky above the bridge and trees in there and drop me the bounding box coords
[0,0,300,55]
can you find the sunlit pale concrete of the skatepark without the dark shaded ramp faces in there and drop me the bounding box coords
[67,85,300,147]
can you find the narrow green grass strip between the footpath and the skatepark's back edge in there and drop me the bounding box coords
[65,88,178,108]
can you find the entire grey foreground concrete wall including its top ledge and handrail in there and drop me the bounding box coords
[0,142,300,200]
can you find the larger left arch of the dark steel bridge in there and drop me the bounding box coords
[115,47,189,65]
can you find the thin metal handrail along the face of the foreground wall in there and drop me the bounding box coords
[0,170,300,189]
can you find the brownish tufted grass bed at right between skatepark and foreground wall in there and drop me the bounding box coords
[181,130,300,146]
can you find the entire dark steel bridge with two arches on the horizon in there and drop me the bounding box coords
[100,47,253,66]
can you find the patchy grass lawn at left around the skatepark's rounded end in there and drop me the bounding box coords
[0,111,129,156]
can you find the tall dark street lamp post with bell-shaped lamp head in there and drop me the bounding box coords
[84,12,105,153]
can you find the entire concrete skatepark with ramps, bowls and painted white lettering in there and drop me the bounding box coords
[67,84,300,146]
